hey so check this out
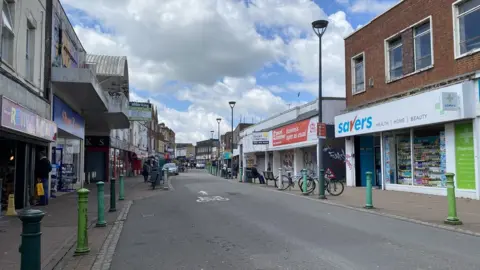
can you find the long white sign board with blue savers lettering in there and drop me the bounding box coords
[335,81,476,138]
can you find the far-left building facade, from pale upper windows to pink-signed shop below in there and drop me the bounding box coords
[0,1,57,209]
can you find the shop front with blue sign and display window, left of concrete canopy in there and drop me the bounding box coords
[51,96,85,192]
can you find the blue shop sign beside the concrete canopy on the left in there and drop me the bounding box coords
[53,96,85,139]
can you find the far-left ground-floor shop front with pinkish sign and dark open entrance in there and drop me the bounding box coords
[0,96,57,210]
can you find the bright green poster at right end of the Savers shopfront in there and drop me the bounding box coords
[455,122,475,190]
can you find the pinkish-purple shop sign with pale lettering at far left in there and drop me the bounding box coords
[0,96,57,142]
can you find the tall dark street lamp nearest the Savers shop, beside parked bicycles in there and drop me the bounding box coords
[312,20,328,200]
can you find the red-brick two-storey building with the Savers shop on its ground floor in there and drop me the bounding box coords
[335,0,480,199]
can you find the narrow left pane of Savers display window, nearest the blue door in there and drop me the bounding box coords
[395,133,412,185]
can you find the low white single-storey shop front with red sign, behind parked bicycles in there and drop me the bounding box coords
[242,117,345,180]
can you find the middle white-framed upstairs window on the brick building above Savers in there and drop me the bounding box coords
[383,15,436,84]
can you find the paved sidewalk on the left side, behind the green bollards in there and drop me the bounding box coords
[0,176,160,270]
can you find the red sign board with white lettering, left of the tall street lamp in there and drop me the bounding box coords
[272,118,318,147]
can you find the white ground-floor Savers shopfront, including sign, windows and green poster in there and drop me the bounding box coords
[335,81,480,199]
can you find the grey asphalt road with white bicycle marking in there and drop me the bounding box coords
[110,170,480,270]
